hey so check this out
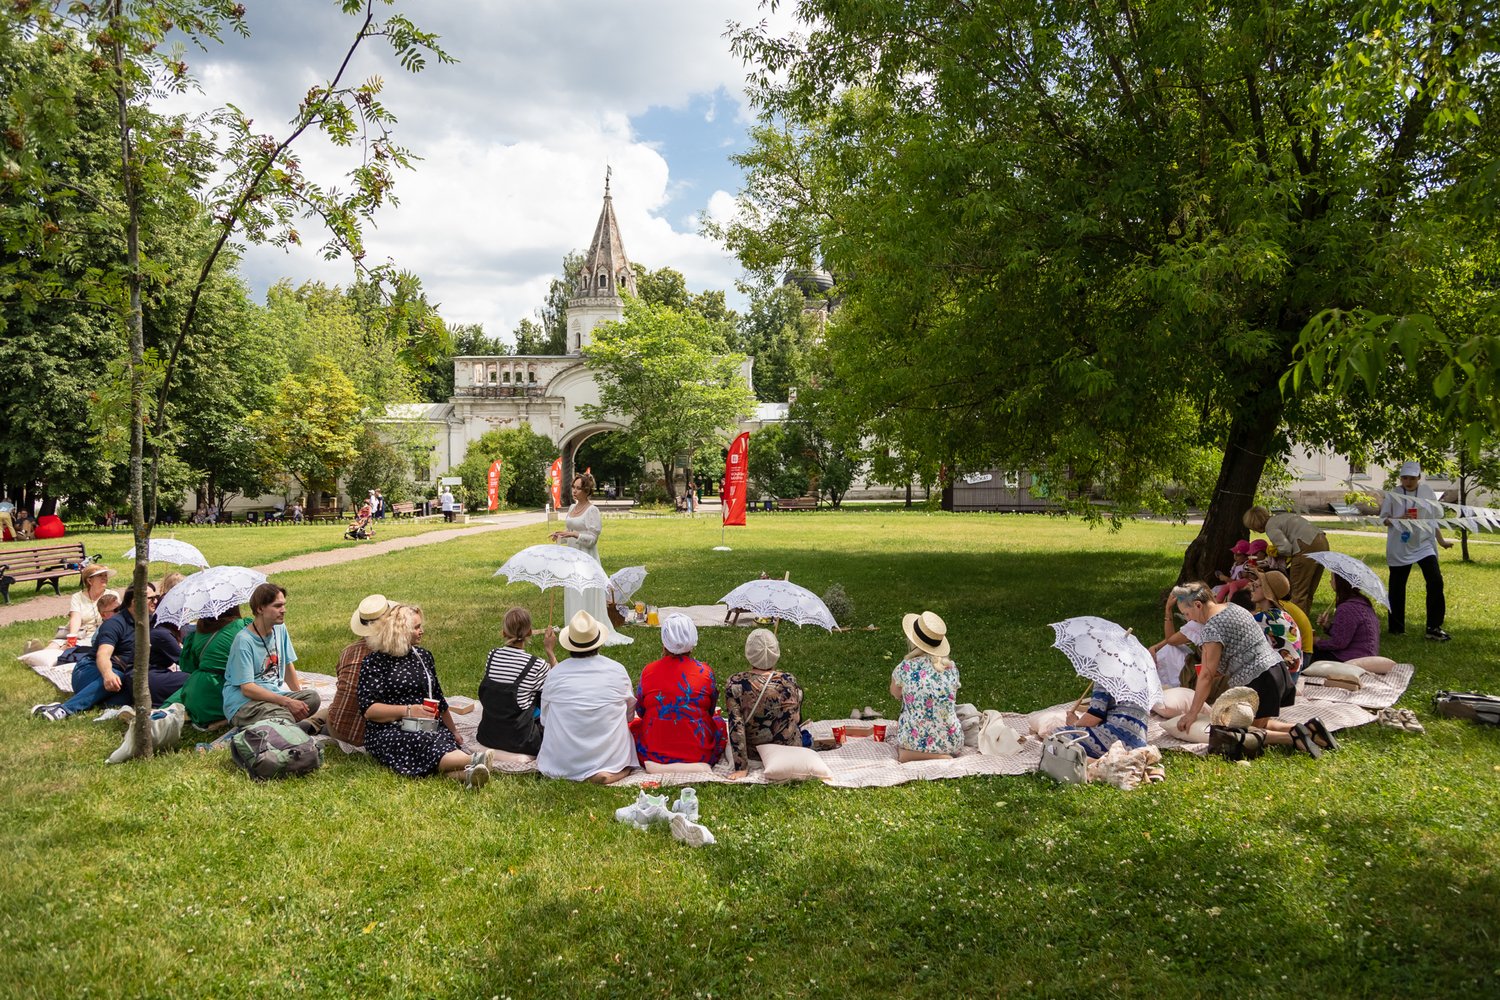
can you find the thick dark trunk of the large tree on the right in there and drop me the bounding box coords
[1178,384,1283,583]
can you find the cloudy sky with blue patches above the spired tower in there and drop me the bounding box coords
[167,0,786,334]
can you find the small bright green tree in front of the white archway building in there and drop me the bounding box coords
[581,300,755,496]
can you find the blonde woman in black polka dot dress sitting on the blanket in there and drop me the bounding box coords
[359,604,489,789]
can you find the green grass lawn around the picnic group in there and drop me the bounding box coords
[0,510,1500,997]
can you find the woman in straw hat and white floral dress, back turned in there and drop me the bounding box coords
[891,612,963,763]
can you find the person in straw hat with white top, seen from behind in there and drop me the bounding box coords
[537,612,636,784]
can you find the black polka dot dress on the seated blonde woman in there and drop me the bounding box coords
[359,646,462,778]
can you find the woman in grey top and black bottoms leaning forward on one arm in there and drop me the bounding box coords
[1167,582,1338,757]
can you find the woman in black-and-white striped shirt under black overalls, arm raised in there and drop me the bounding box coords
[479,607,558,757]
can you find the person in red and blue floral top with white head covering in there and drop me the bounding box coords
[630,612,725,771]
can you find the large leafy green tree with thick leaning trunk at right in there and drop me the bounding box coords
[725,0,1496,576]
